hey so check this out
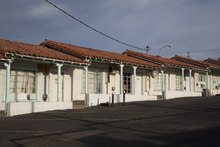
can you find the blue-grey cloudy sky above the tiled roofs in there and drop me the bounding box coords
[0,0,220,60]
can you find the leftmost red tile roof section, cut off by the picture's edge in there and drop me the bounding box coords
[0,39,86,64]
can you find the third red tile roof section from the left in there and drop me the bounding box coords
[124,50,205,69]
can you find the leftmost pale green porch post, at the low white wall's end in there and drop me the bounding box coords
[4,60,11,115]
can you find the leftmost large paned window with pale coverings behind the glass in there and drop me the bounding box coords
[10,70,36,94]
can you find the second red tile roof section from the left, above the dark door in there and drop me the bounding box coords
[41,39,160,68]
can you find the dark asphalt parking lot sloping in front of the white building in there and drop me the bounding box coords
[0,96,220,147]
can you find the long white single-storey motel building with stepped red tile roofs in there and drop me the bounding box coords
[0,39,220,116]
